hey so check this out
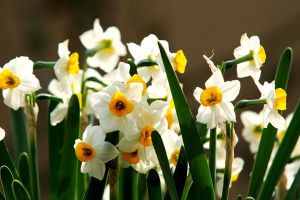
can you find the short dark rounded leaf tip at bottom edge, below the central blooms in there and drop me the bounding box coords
[147,169,162,200]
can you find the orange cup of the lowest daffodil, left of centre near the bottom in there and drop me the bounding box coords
[75,142,96,162]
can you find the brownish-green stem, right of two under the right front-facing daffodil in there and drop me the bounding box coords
[221,122,234,200]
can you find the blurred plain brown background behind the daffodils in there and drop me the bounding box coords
[0,0,300,199]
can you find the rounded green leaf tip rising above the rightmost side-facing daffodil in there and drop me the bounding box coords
[275,47,293,90]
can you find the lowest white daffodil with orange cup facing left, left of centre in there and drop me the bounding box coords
[74,125,119,180]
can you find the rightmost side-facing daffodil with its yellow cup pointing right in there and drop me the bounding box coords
[255,81,287,130]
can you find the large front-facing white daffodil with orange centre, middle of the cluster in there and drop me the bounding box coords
[90,82,143,134]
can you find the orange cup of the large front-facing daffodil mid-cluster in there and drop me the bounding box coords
[109,92,134,117]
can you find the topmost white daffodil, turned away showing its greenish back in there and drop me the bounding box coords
[79,19,126,73]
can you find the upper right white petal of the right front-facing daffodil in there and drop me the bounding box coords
[220,80,241,101]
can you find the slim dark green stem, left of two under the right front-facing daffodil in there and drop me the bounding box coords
[209,128,217,188]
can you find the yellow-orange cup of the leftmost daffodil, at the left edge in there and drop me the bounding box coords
[0,69,20,90]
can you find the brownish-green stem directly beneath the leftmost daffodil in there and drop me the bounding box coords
[25,95,40,200]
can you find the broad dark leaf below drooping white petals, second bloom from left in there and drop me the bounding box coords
[48,100,65,200]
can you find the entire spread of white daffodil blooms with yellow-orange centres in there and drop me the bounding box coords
[0,19,300,200]
